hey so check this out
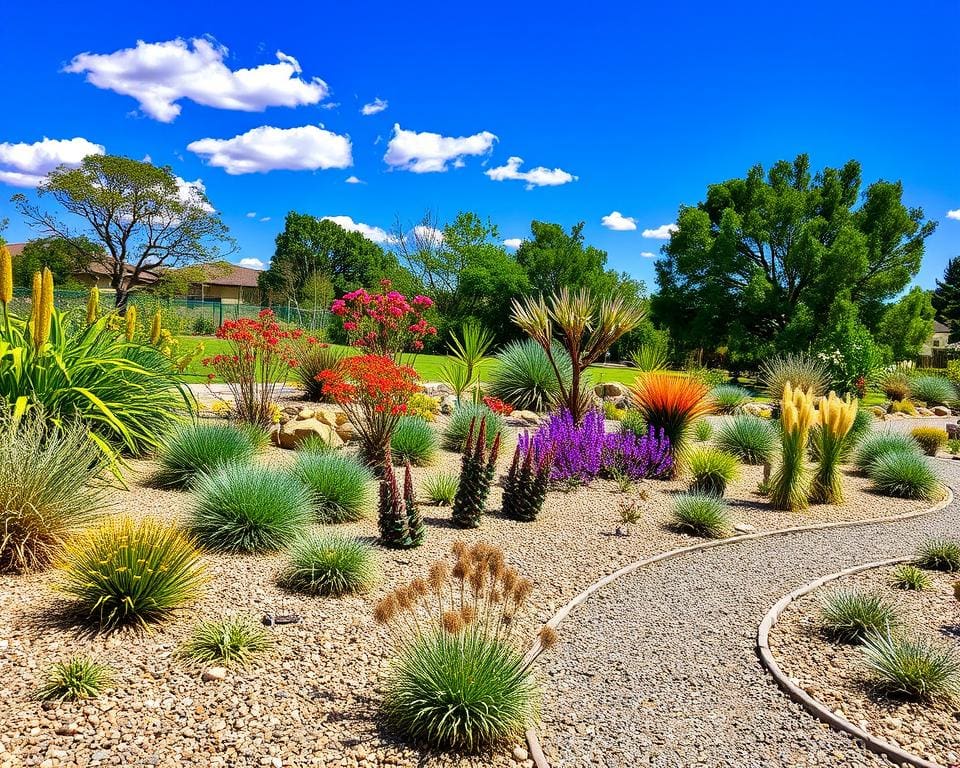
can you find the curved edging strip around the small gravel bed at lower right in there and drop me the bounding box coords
[757,557,943,768]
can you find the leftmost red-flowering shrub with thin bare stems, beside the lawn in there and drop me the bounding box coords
[203,309,303,426]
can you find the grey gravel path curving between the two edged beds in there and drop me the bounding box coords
[541,462,960,768]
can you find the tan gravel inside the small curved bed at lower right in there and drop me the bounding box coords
[770,567,960,765]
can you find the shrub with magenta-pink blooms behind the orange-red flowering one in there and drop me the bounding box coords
[330,280,437,360]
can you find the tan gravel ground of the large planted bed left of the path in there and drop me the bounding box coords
[0,418,930,768]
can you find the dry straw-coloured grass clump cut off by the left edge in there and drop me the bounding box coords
[0,409,105,573]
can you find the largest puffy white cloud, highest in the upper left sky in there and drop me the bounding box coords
[64,38,329,123]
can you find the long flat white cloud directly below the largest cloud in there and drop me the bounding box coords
[187,125,353,176]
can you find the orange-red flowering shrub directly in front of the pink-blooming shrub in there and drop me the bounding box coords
[317,355,418,468]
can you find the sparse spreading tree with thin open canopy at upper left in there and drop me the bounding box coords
[13,155,234,313]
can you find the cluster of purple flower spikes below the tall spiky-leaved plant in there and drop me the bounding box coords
[520,410,673,483]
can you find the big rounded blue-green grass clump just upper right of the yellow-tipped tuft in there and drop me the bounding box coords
[191,462,312,552]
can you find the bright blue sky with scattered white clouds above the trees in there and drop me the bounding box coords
[0,0,960,287]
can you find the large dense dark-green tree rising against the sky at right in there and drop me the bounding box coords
[652,155,936,364]
